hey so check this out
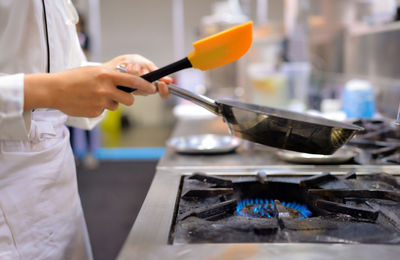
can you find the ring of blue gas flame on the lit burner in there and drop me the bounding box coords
[236,199,312,219]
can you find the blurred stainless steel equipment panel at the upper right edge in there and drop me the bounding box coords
[344,22,400,119]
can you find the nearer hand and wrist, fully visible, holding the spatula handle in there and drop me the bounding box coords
[24,66,156,117]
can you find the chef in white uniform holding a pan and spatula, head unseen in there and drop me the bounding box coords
[0,0,170,260]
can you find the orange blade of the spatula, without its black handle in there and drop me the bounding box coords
[187,22,253,70]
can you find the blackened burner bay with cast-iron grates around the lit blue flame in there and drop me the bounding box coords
[169,171,400,244]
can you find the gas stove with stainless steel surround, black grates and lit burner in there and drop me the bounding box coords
[118,165,400,260]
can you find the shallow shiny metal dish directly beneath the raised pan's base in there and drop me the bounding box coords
[277,147,357,164]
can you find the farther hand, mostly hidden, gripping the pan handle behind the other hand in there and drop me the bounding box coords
[102,54,172,99]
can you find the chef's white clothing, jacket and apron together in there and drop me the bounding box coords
[0,0,97,260]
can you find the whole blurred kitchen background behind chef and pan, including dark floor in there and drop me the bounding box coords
[72,0,400,259]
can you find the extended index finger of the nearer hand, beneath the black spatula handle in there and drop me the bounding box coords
[110,72,156,94]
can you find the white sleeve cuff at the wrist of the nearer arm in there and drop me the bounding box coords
[0,74,30,140]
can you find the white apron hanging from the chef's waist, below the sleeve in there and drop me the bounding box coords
[0,111,92,260]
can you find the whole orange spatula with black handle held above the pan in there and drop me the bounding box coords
[118,22,253,92]
